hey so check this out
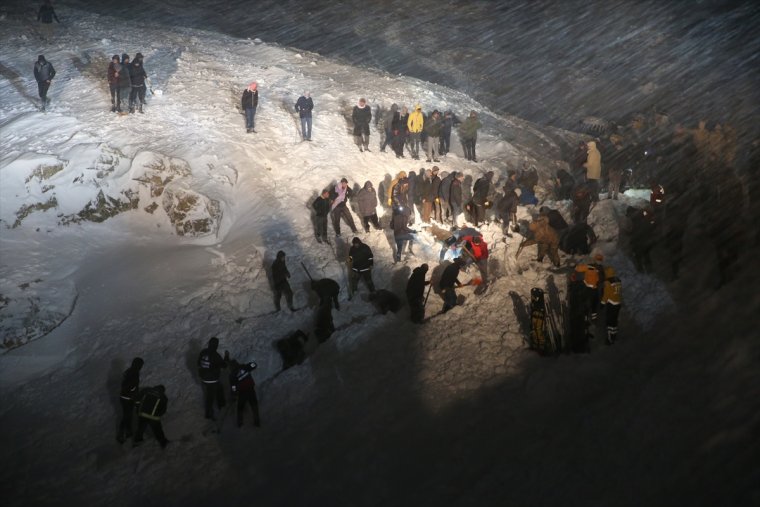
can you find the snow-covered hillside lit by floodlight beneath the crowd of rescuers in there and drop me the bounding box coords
[0,4,760,506]
